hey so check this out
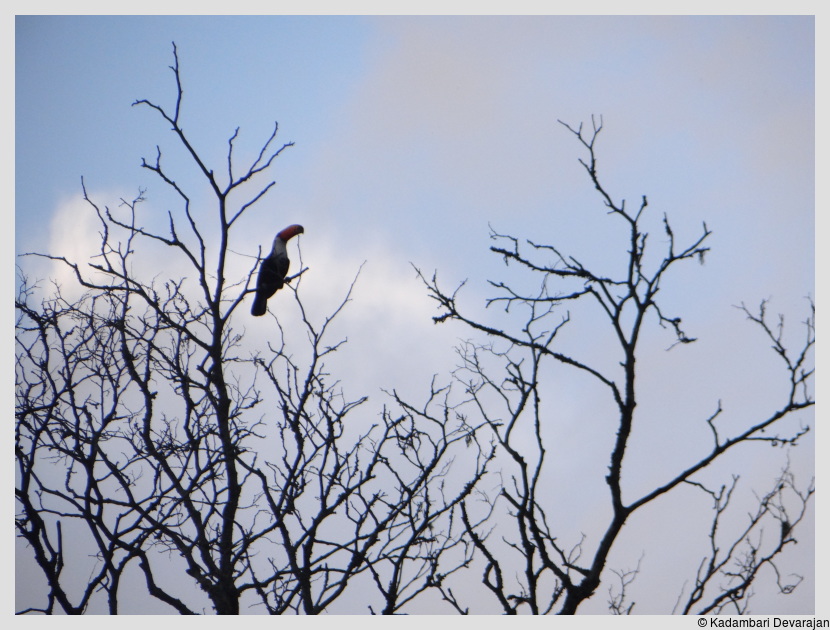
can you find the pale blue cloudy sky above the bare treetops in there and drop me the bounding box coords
[9,4,827,624]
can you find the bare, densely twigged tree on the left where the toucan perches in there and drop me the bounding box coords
[15,45,492,614]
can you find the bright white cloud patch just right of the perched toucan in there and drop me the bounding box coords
[275,232,456,402]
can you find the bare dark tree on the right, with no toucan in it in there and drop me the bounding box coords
[418,119,815,614]
